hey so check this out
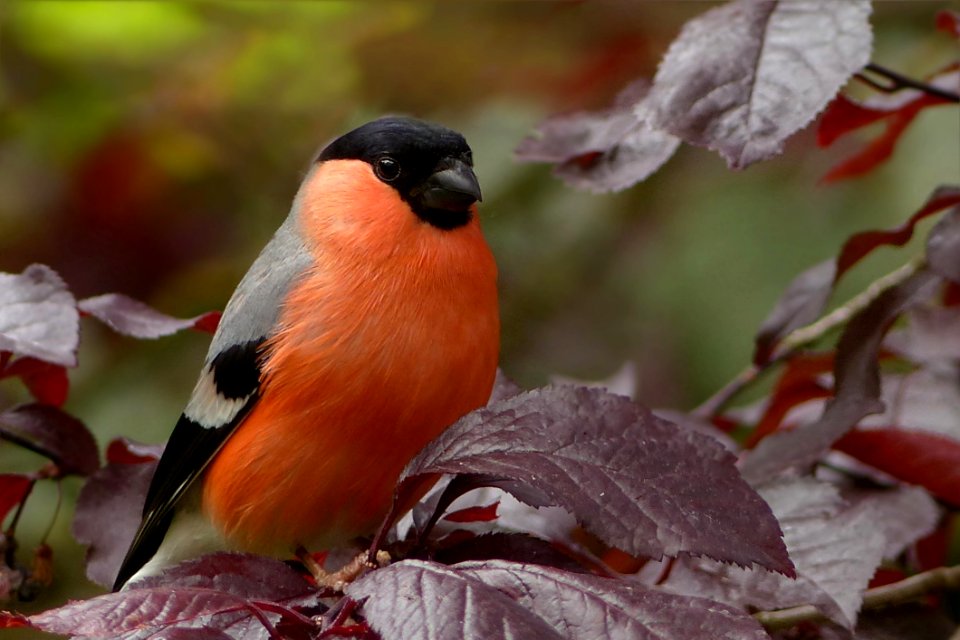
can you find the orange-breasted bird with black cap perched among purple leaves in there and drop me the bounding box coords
[114,116,500,590]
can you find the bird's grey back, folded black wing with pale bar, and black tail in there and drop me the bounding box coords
[114,215,311,590]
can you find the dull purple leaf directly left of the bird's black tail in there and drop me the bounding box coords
[72,462,157,587]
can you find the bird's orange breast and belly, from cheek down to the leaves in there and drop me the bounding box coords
[203,161,499,554]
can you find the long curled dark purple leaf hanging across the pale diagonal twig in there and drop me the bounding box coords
[740,270,940,485]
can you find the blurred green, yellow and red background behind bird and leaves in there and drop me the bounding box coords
[0,0,960,611]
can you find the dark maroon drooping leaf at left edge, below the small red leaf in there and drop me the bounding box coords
[0,404,100,476]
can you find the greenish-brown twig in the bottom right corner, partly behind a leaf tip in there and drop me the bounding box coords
[753,565,960,630]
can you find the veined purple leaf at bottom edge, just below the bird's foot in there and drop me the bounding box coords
[346,560,564,640]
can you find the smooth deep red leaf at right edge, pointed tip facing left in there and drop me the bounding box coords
[834,427,960,506]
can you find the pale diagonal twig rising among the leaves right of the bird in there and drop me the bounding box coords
[691,257,924,419]
